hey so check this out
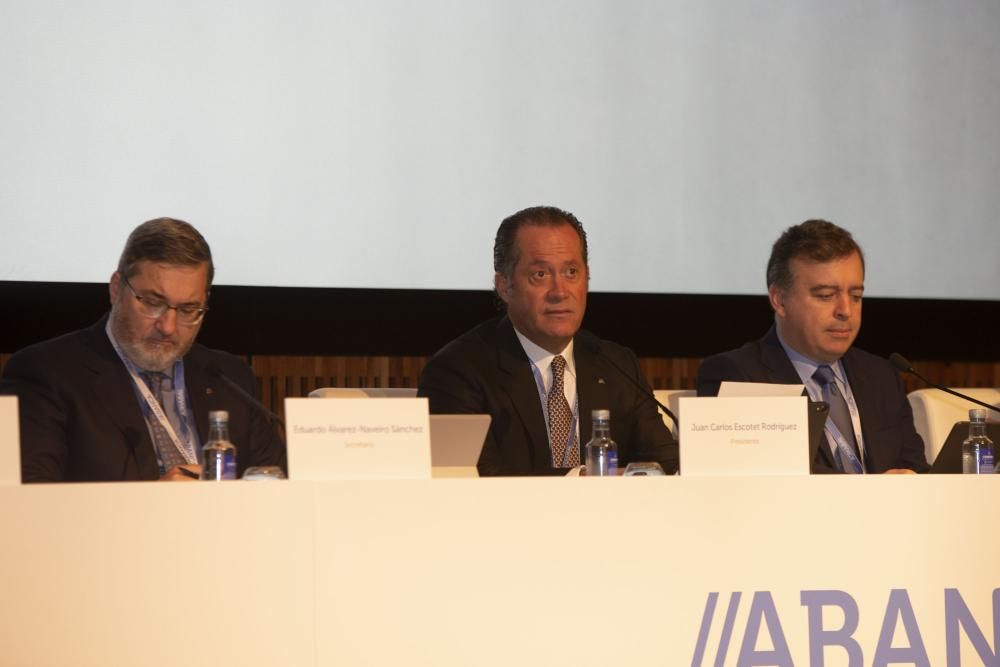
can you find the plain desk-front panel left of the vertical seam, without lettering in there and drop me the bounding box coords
[0,482,315,667]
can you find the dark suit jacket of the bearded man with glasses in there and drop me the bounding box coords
[0,316,285,482]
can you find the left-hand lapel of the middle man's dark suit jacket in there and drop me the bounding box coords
[497,317,551,465]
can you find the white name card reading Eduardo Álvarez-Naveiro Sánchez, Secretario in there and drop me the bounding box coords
[285,398,431,480]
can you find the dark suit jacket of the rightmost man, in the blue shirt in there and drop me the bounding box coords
[698,327,929,473]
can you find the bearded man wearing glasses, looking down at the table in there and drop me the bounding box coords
[0,218,285,482]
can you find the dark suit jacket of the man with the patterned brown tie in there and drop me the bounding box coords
[419,317,677,475]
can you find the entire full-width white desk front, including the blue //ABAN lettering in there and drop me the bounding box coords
[0,475,1000,667]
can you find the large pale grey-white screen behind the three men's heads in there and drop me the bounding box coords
[0,0,1000,298]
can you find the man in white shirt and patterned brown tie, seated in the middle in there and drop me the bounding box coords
[419,206,677,475]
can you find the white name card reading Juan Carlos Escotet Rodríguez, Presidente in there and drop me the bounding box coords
[680,396,809,475]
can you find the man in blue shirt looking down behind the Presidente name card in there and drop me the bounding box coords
[698,220,929,473]
